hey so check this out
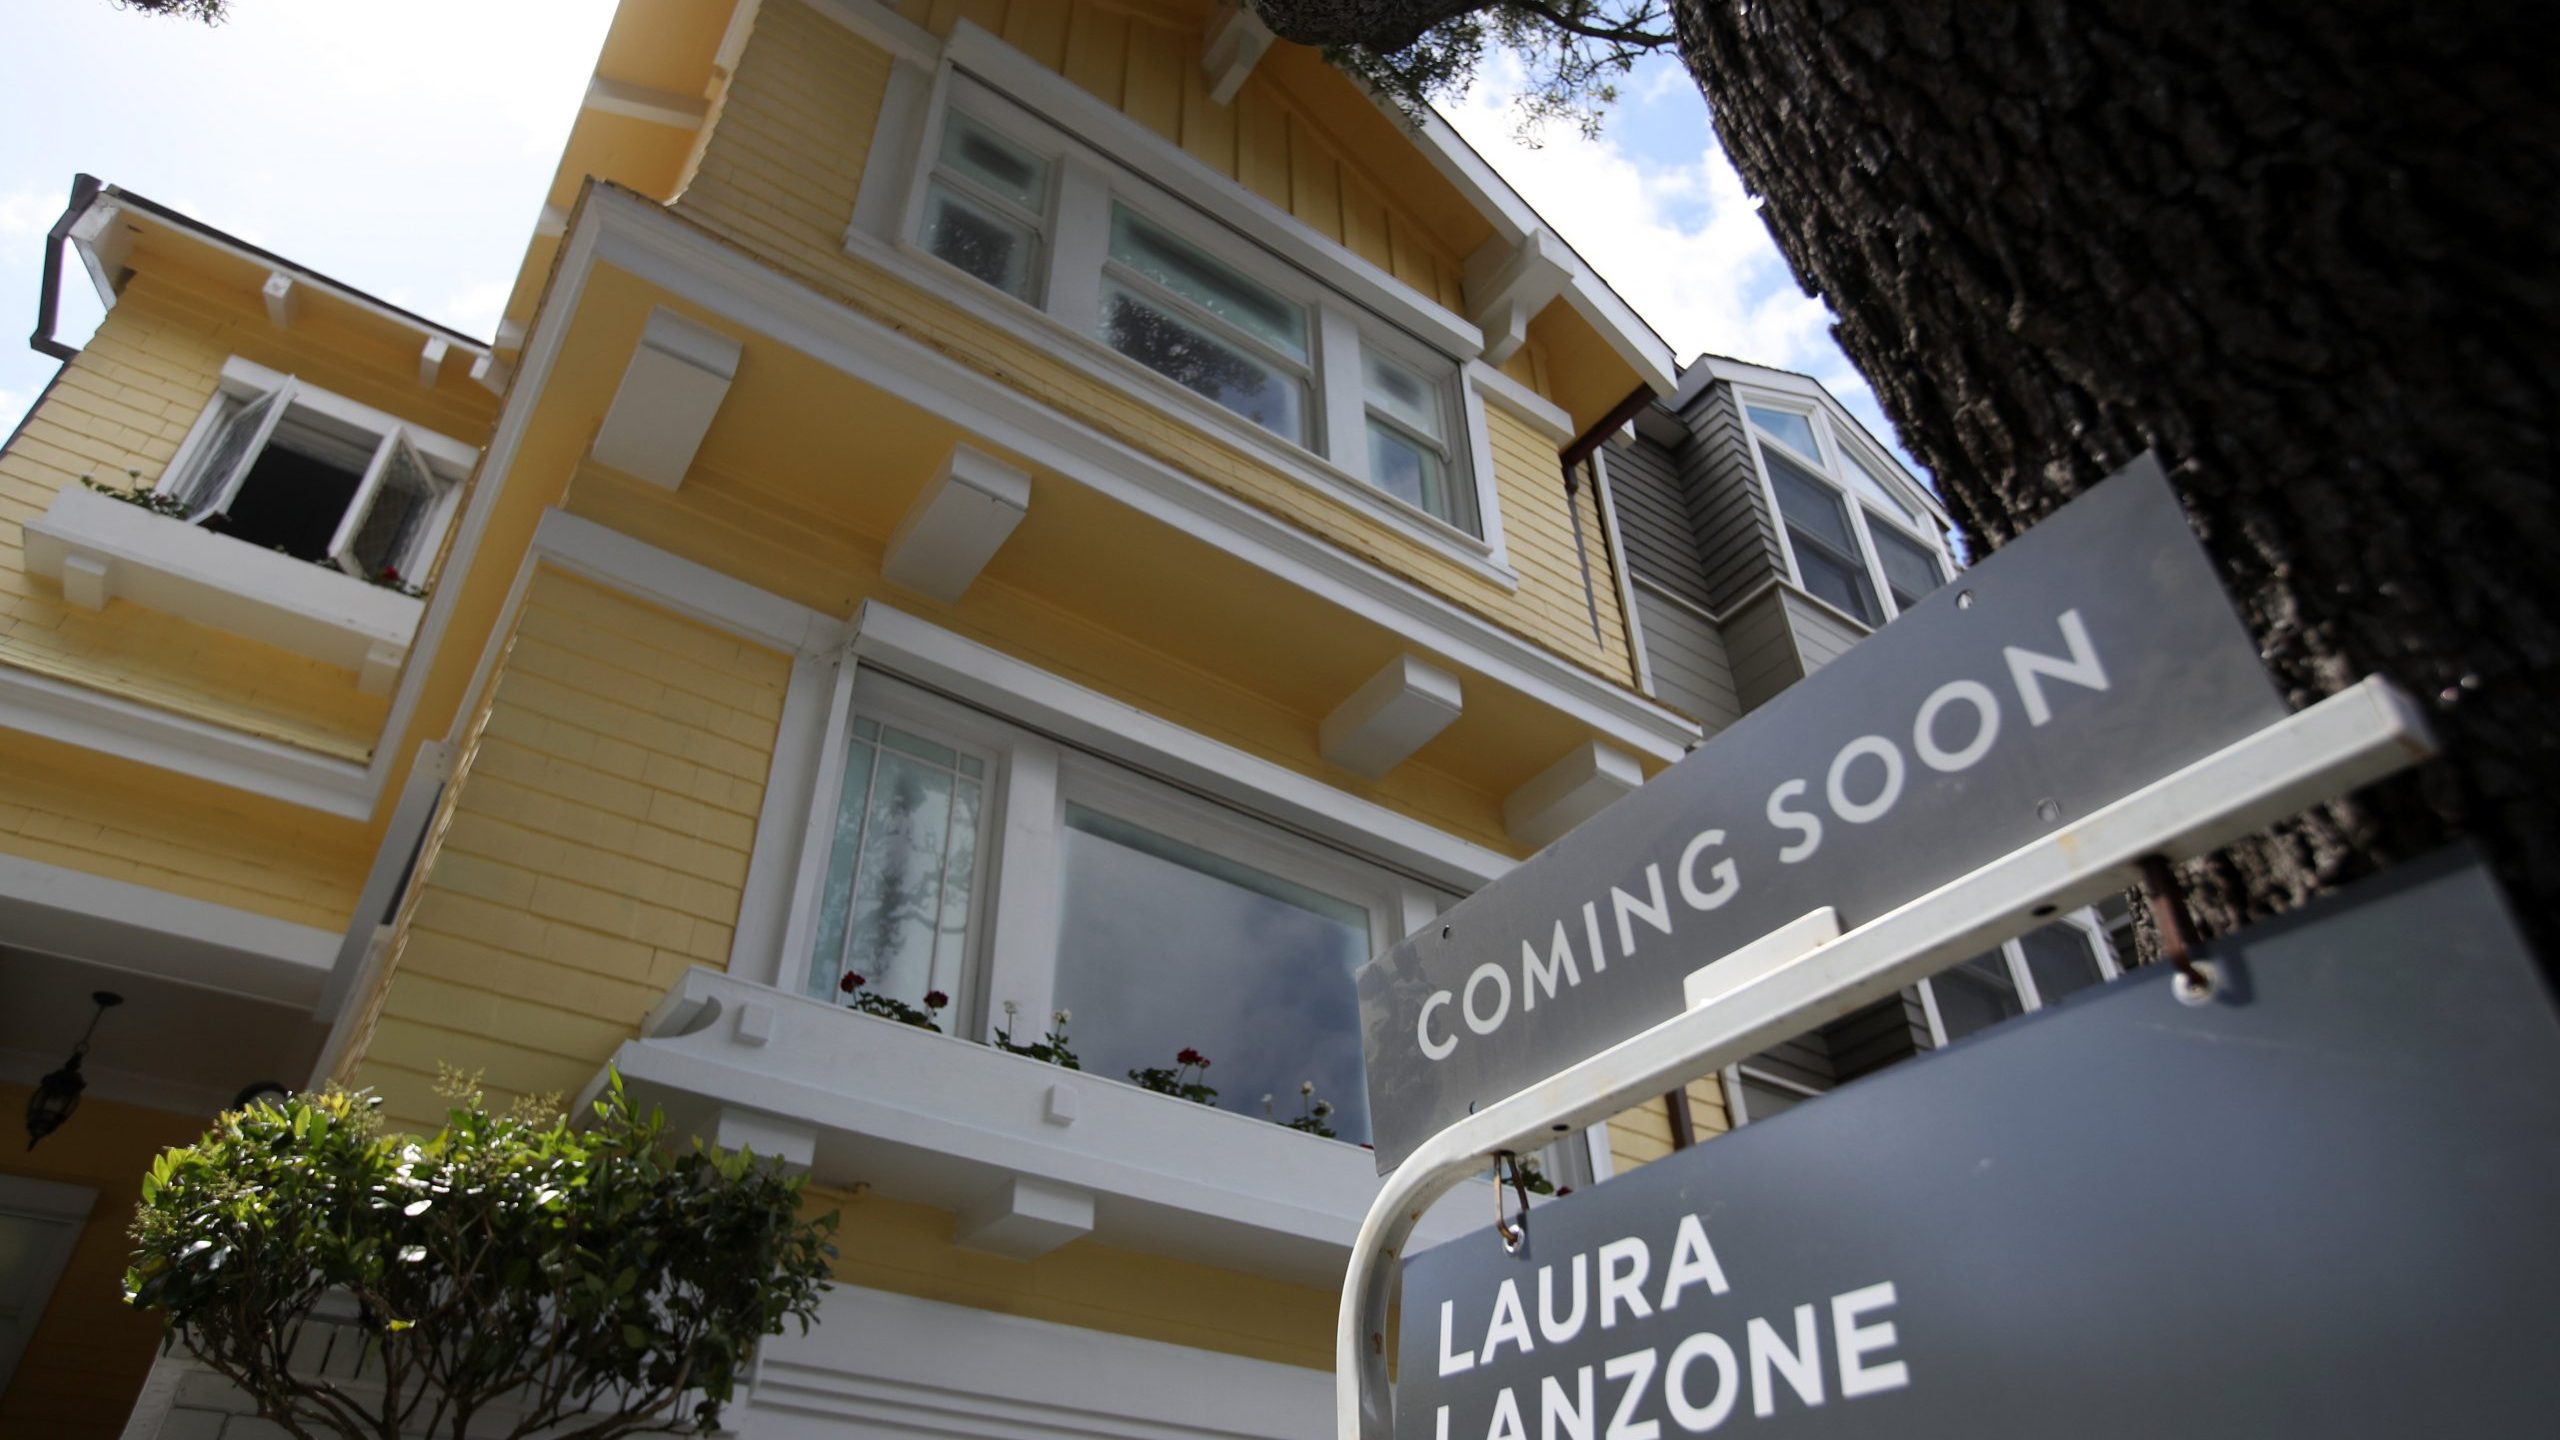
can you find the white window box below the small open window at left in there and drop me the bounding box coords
[26,487,425,694]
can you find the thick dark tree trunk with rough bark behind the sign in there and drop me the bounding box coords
[1677,0,2560,956]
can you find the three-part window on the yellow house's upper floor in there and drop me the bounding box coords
[880,72,1495,538]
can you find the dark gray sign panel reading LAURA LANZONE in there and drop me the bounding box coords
[1395,853,2560,1440]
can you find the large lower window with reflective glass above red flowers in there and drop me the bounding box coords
[791,671,1446,1140]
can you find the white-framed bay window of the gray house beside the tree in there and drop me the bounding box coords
[1743,400,1948,625]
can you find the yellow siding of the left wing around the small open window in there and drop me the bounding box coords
[0,277,481,761]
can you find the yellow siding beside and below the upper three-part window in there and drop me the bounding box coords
[676,5,1633,684]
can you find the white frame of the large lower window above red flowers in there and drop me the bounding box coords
[773,661,1454,1137]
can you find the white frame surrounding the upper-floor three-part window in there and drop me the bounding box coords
[845,23,1518,576]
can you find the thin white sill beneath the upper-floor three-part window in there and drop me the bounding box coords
[845,231,1521,592]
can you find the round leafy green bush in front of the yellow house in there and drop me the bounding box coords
[125,1076,835,1440]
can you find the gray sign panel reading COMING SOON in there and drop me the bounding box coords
[1359,456,2286,1174]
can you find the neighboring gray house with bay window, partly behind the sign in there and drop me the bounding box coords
[1600,356,2117,1133]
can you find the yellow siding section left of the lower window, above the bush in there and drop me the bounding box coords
[353,571,791,1125]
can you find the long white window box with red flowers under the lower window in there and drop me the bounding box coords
[589,969,1485,1286]
